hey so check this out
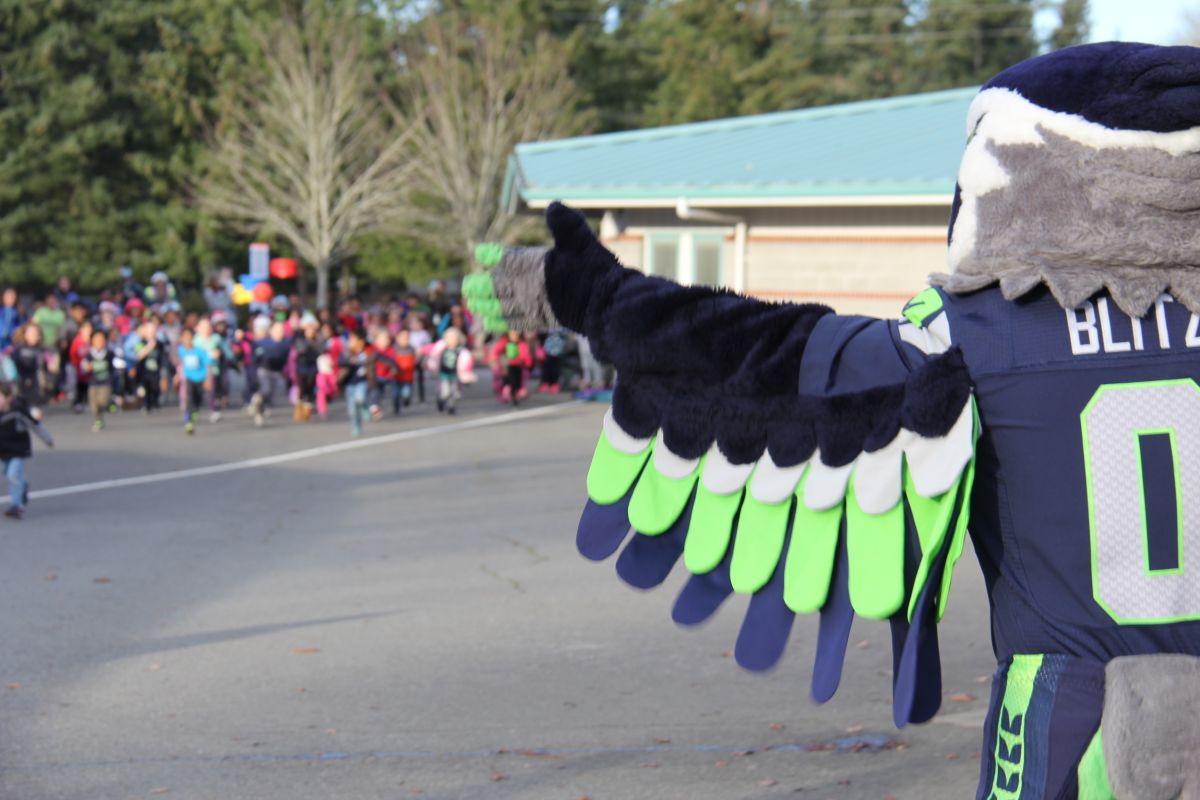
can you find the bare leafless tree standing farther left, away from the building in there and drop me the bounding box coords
[198,4,415,307]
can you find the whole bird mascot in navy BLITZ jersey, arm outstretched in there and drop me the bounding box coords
[464,43,1200,800]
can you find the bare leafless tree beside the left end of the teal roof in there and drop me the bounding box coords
[404,11,588,260]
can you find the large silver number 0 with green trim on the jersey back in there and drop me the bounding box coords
[1080,379,1200,625]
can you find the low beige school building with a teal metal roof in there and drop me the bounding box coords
[503,88,978,317]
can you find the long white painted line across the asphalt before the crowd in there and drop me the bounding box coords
[12,399,583,503]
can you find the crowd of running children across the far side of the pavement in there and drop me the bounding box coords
[0,278,611,517]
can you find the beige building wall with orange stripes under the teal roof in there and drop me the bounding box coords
[595,205,949,317]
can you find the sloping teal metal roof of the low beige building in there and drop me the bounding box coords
[504,88,978,203]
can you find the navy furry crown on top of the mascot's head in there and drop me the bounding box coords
[984,42,1200,133]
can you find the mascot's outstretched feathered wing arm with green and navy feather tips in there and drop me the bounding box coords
[463,204,978,724]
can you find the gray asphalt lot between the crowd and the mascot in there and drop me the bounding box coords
[0,387,992,800]
